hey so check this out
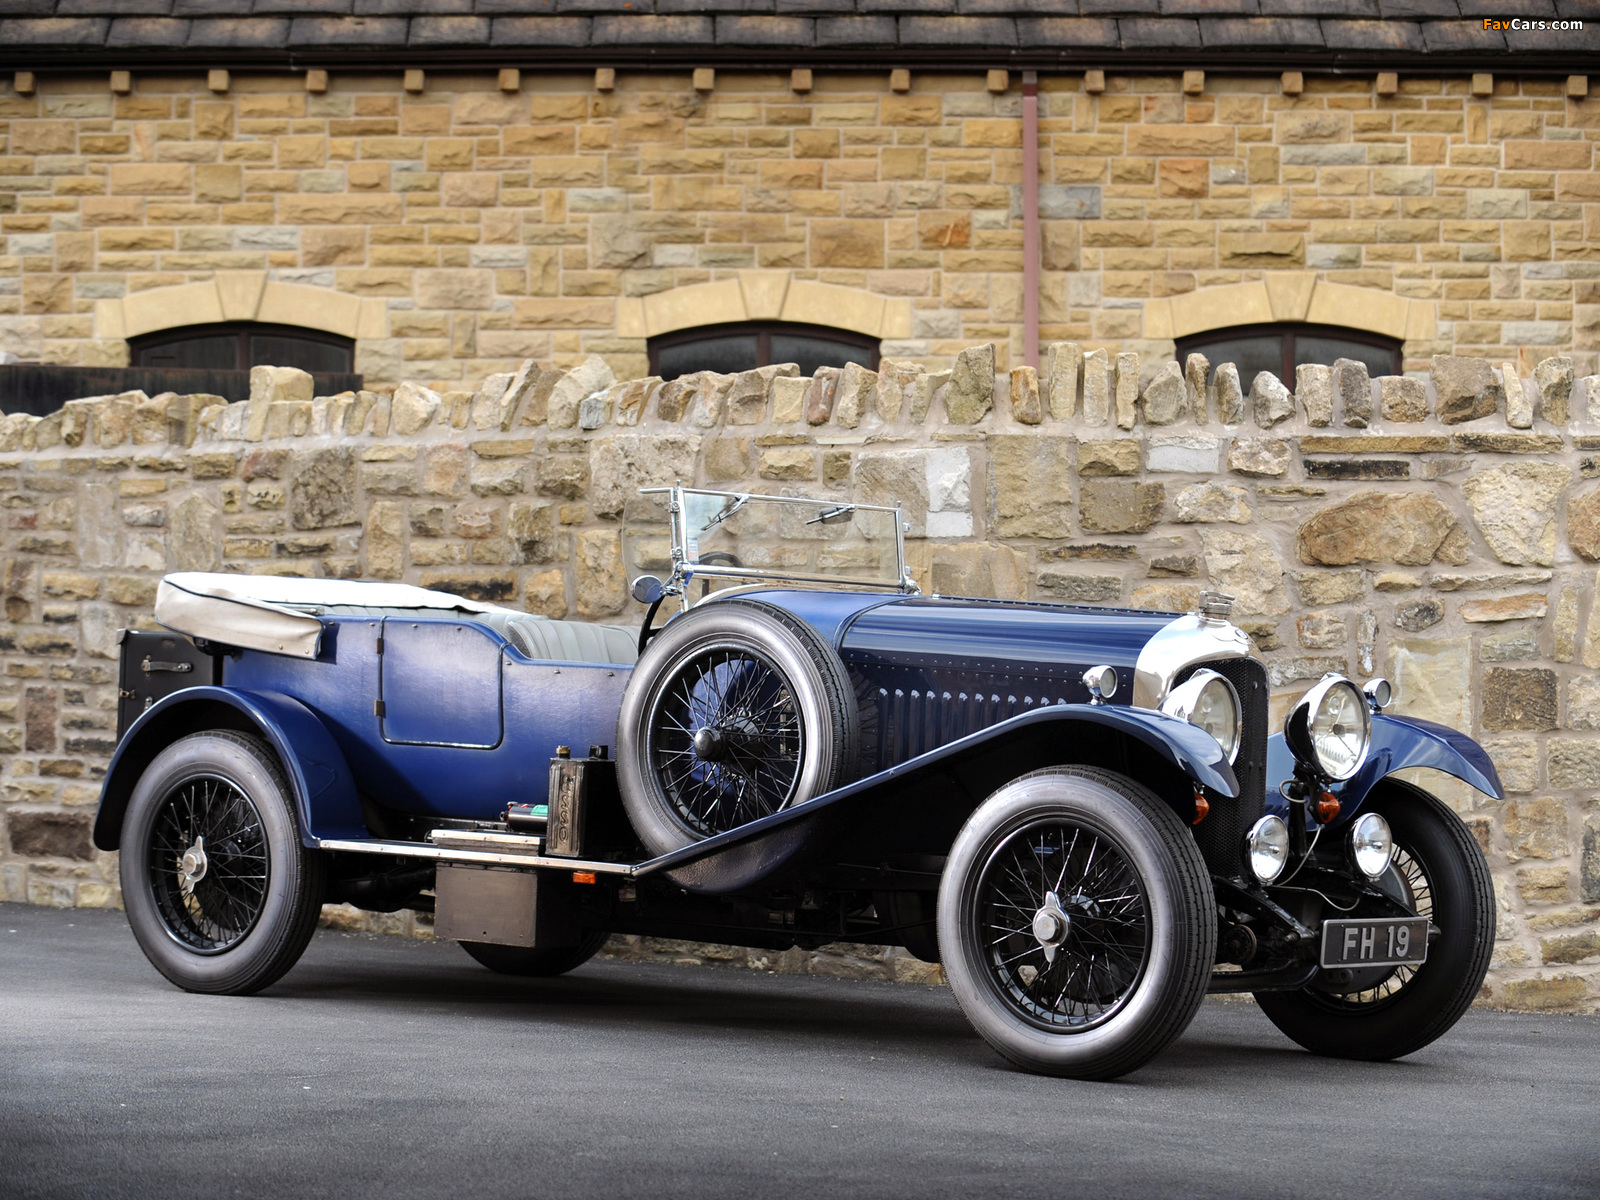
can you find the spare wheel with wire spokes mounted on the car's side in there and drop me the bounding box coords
[616,600,861,854]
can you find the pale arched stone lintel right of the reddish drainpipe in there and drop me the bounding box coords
[1144,270,1435,341]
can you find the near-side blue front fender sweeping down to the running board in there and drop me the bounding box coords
[638,704,1238,893]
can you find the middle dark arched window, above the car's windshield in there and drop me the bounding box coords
[650,322,878,379]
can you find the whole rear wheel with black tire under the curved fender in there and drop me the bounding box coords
[120,730,326,995]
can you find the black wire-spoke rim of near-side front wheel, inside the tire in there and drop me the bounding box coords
[974,819,1150,1034]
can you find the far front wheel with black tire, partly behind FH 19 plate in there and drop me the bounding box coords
[1256,779,1494,1062]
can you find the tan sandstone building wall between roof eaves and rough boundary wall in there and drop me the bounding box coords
[0,70,1600,387]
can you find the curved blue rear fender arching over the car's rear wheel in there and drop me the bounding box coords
[94,686,371,850]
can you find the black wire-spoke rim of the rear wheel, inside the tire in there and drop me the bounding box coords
[146,774,270,954]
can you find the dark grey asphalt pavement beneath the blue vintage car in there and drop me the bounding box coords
[0,904,1600,1200]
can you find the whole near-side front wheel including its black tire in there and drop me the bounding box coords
[939,766,1216,1078]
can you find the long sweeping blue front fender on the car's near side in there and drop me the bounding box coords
[638,704,1238,894]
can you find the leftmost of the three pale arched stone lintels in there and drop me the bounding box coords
[94,270,389,341]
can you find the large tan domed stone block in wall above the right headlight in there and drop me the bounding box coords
[1294,491,1467,566]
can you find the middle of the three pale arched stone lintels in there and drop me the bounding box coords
[616,270,910,339]
